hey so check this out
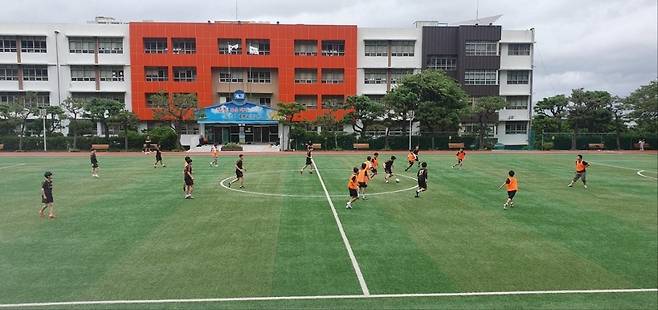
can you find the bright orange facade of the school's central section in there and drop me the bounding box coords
[130,22,357,120]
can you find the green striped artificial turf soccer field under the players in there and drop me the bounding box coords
[0,152,658,309]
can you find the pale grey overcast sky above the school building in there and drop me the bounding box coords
[0,0,658,101]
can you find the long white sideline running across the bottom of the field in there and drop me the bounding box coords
[0,288,658,308]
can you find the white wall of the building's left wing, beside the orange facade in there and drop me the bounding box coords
[0,23,132,116]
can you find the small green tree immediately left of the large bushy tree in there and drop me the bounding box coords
[344,95,385,135]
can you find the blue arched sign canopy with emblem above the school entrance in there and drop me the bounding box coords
[198,90,278,125]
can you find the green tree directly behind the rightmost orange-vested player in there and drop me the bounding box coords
[567,88,613,149]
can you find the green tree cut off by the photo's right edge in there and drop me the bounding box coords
[624,80,658,134]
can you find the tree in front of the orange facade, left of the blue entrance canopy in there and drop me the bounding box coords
[150,91,199,149]
